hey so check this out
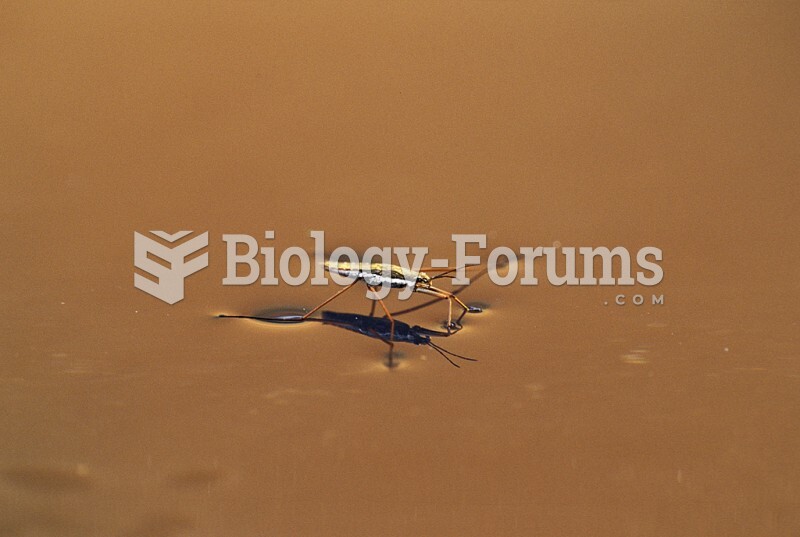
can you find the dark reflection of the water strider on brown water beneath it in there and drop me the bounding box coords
[218,311,478,368]
